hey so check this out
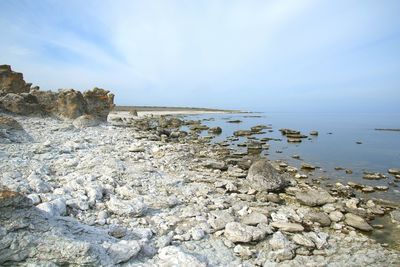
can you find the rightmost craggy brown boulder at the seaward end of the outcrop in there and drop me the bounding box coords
[83,87,114,121]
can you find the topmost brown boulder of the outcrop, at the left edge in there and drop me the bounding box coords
[0,65,31,94]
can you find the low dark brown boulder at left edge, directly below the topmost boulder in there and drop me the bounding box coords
[0,93,42,115]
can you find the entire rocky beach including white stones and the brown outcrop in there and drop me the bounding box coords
[0,65,400,267]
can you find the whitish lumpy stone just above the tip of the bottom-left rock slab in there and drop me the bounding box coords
[106,196,147,217]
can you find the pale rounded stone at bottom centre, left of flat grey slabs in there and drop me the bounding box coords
[224,222,265,243]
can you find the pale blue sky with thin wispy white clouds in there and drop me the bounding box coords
[0,0,400,112]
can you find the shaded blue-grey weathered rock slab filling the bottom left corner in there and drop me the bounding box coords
[0,191,141,266]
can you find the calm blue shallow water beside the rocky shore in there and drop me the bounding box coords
[182,113,400,203]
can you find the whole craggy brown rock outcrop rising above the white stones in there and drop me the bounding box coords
[0,65,114,120]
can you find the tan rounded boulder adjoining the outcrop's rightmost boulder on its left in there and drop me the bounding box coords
[57,89,87,119]
